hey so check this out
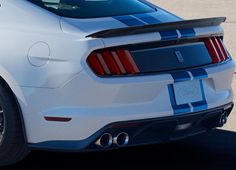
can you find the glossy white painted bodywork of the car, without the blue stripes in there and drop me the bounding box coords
[0,0,234,143]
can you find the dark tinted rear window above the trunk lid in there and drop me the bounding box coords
[28,0,155,18]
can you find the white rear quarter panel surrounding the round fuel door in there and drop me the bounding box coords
[0,0,104,88]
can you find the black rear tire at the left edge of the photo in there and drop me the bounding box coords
[0,83,29,166]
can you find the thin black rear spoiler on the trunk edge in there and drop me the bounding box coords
[86,17,226,38]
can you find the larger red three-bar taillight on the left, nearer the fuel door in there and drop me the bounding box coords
[87,49,140,76]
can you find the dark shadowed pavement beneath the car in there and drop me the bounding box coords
[1,130,236,170]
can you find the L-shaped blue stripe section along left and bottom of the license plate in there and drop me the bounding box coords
[168,84,191,115]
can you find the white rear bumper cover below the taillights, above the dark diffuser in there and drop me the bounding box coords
[18,61,234,144]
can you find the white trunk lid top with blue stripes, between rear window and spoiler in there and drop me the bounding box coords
[61,9,181,36]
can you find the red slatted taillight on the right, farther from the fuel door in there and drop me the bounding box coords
[204,37,229,63]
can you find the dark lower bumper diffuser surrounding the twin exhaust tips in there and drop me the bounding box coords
[29,103,234,152]
